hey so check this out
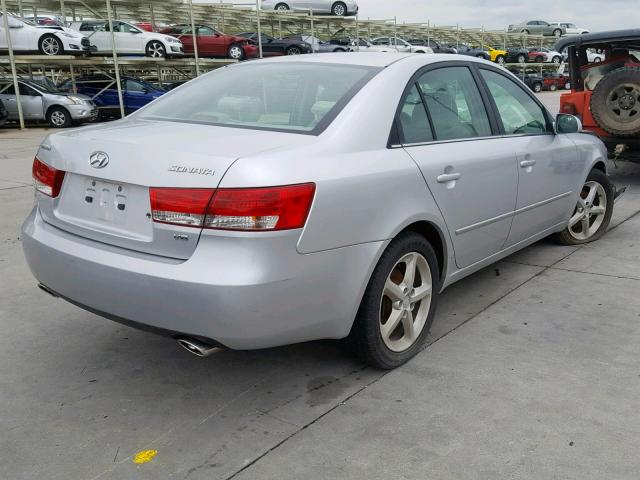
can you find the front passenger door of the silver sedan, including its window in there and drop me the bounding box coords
[479,66,583,246]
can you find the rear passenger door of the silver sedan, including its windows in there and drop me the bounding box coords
[397,62,518,268]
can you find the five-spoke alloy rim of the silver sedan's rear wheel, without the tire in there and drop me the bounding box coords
[379,252,432,352]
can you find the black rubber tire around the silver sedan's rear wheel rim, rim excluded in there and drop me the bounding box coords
[345,232,440,370]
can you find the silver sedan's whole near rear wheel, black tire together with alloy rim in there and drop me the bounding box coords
[346,232,440,370]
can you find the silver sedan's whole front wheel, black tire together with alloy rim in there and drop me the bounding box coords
[554,169,614,245]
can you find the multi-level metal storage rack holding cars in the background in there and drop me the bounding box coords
[0,0,557,128]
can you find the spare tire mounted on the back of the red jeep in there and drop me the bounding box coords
[591,67,640,137]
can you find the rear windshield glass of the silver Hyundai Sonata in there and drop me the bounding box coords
[139,62,380,135]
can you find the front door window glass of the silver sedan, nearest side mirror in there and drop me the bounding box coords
[480,69,547,135]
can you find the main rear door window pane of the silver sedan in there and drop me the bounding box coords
[418,67,491,140]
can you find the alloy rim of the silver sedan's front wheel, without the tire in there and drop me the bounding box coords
[569,182,607,240]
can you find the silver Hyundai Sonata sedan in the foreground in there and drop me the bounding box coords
[23,53,614,368]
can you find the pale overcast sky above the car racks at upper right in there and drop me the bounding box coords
[358,0,640,31]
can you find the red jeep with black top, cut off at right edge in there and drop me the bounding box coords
[556,29,640,161]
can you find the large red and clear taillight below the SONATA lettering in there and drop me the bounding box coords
[150,183,316,231]
